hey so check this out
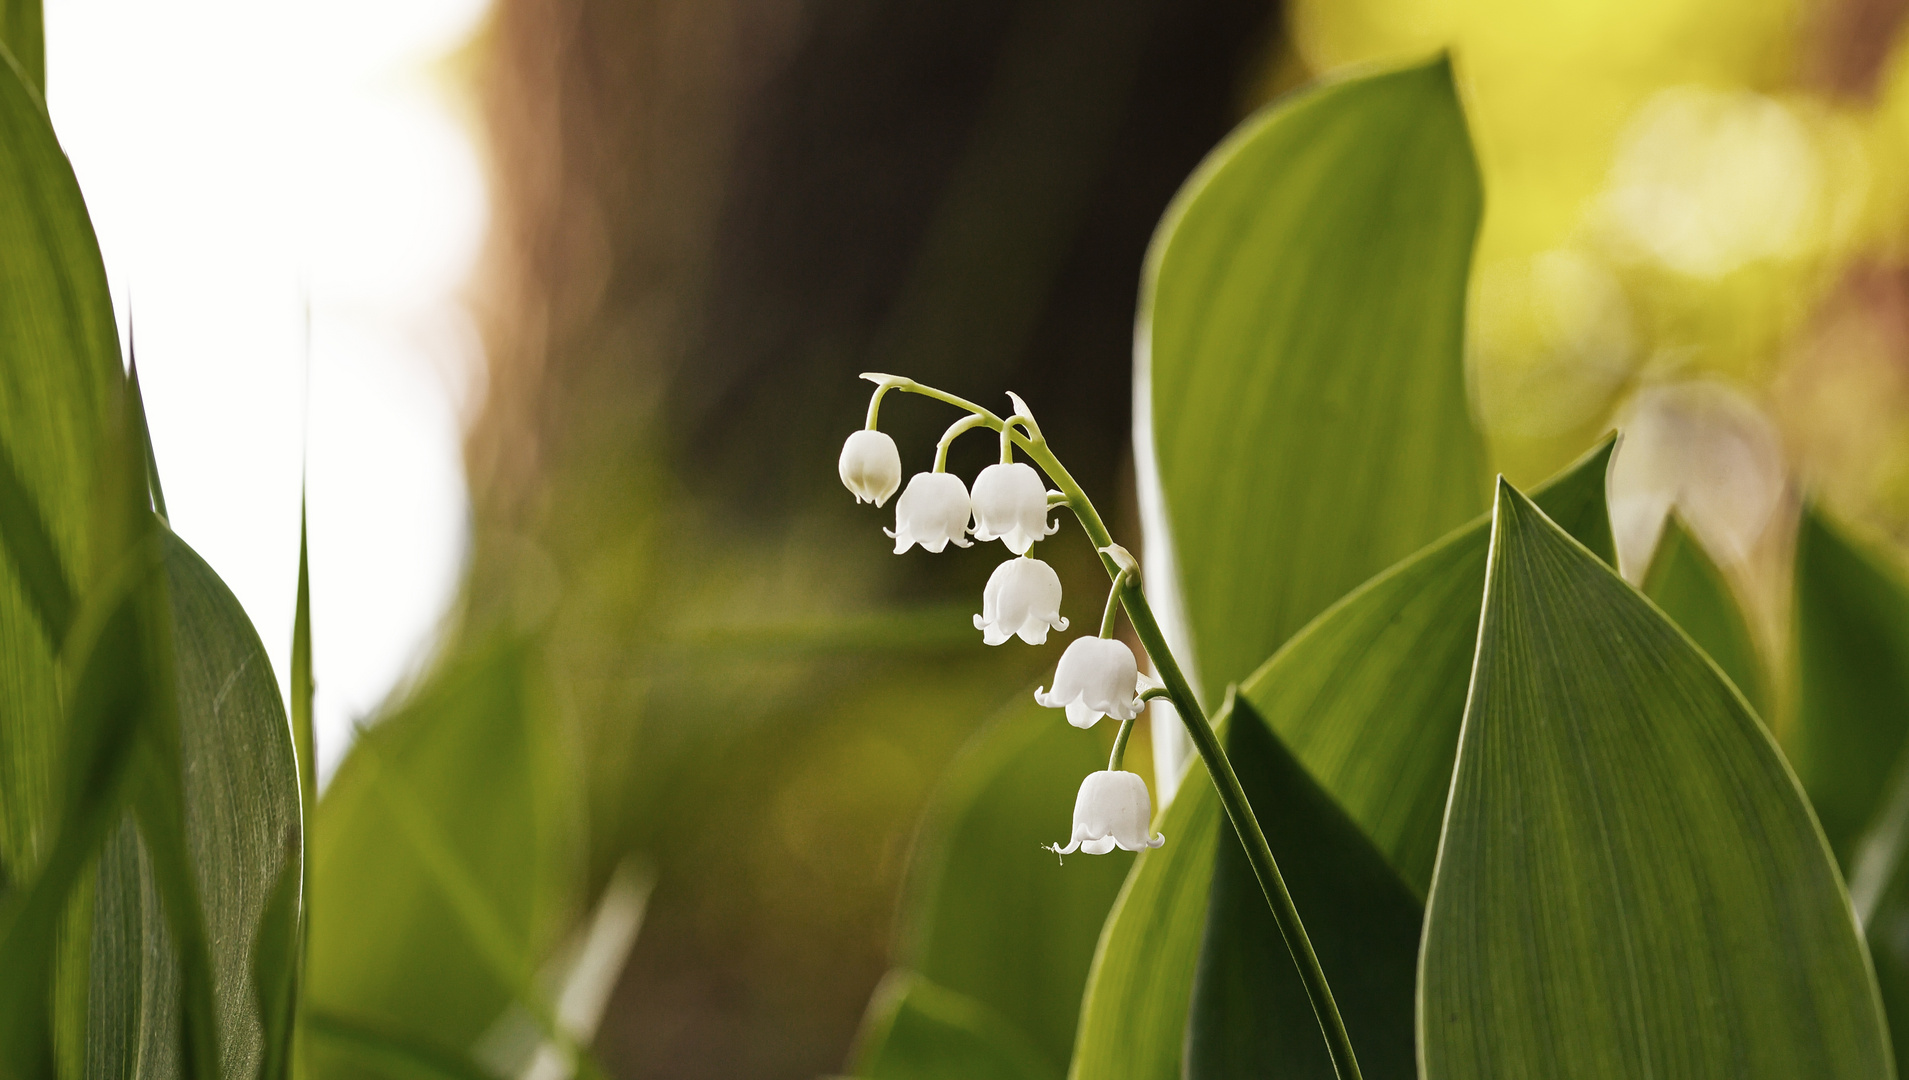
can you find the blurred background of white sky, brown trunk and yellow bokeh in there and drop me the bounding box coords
[46,0,1909,1078]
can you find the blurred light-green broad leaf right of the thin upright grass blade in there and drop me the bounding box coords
[304,641,578,1076]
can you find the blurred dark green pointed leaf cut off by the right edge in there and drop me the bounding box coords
[1787,506,1909,874]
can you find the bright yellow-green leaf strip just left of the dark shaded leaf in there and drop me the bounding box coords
[1067,767,1229,1080]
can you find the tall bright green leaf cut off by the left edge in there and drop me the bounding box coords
[0,10,120,904]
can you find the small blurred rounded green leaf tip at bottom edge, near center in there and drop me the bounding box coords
[855,971,1059,1080]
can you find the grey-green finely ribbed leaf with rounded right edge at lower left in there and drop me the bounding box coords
[79,532,302,1076]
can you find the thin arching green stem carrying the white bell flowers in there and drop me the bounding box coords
[863,374,1361,1080]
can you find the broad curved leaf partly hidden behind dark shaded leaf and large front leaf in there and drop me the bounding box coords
[1075,439,1615,1080]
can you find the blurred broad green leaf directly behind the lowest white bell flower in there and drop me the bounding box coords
[857,695,1134,1078]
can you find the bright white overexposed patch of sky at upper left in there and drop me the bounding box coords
[46,0,489,777]
